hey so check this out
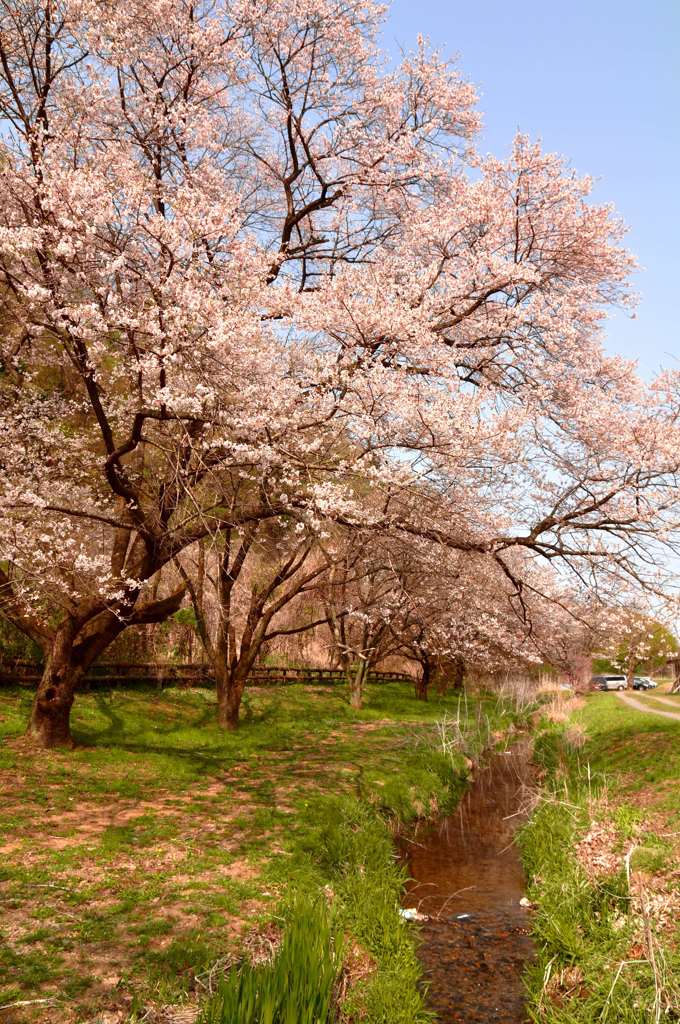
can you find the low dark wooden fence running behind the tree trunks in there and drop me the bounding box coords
[0,660,412,690]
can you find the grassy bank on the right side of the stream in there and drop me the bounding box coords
[521,694,680,1024]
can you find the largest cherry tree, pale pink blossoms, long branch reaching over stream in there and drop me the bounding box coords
[0,0,679,746]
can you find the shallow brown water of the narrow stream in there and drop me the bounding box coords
[403,746,533,1024]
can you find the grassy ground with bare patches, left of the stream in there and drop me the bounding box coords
[0,684,516,1024]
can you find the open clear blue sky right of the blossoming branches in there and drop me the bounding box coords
[383,0,680,377]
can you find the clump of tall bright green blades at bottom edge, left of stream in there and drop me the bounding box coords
[199,897,342,1024]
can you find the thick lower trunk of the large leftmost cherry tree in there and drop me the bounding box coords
[28,635,83,750]
